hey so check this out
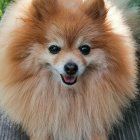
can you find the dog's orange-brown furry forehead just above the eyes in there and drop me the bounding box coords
[46,15,93,46]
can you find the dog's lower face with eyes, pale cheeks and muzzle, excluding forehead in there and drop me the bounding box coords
[40,33,89,85]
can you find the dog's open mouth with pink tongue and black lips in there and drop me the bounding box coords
[61,75,77,85]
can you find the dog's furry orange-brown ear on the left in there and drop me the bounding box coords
[31,0,58,20]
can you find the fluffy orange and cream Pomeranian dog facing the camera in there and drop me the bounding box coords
[0,0,137,140]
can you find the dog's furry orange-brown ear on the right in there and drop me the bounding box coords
[82,0,107,19]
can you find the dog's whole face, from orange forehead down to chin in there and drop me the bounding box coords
[40,15,103,85]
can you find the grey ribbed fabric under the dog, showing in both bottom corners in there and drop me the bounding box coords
[0,94,140,140]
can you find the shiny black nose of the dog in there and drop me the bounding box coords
[64,63,78,75]
